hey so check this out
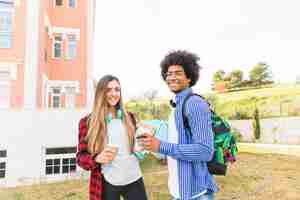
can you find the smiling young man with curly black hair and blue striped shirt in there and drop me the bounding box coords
[140,51,218,200]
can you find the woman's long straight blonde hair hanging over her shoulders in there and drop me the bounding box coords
[85,75,135,155]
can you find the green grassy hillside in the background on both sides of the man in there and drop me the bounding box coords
[126,85,300,120]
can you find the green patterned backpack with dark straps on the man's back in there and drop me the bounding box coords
[182,93,237,175]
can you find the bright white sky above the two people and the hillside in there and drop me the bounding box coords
[93,0,300,98]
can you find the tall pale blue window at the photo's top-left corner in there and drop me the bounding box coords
[0,1,13,48]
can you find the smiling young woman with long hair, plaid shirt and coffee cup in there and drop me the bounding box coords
[77,75,147,200]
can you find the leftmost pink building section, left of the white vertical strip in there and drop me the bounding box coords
[0,0,26,108]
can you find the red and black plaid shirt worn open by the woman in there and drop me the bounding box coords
[76,117,102,200]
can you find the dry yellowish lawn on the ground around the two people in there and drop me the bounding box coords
[0,153,300,200]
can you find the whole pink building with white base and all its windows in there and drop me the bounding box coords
[0,0,95,187]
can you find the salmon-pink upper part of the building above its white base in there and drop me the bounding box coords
[0,0,93,109]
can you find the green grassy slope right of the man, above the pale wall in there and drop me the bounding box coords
[211,85,300,119]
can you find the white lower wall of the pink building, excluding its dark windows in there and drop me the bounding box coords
[0,110,87,186]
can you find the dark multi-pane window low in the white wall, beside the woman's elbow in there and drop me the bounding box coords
[45,147,76,175]
